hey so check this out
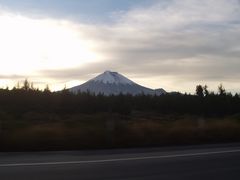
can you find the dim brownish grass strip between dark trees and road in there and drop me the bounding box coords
[0,112,240,151]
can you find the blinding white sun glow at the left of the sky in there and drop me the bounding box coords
[0,13,99,79]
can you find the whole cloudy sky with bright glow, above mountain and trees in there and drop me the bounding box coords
[0,0,240,93]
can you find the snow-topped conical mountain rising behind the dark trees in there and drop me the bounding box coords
[69,71,166,95]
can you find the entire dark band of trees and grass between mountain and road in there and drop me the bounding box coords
[0,80,240,151]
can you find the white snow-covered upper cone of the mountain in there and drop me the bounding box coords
[91,71,134,84]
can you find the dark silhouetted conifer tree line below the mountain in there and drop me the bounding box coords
[0,80,240,116]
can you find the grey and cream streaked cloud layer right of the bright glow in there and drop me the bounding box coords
[0,0,240,92]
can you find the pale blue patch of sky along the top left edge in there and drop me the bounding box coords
[0,0,156,23]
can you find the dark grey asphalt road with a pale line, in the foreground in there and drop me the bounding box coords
[0,144,240,180]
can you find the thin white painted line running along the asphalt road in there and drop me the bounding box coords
[0,149,240,167]
